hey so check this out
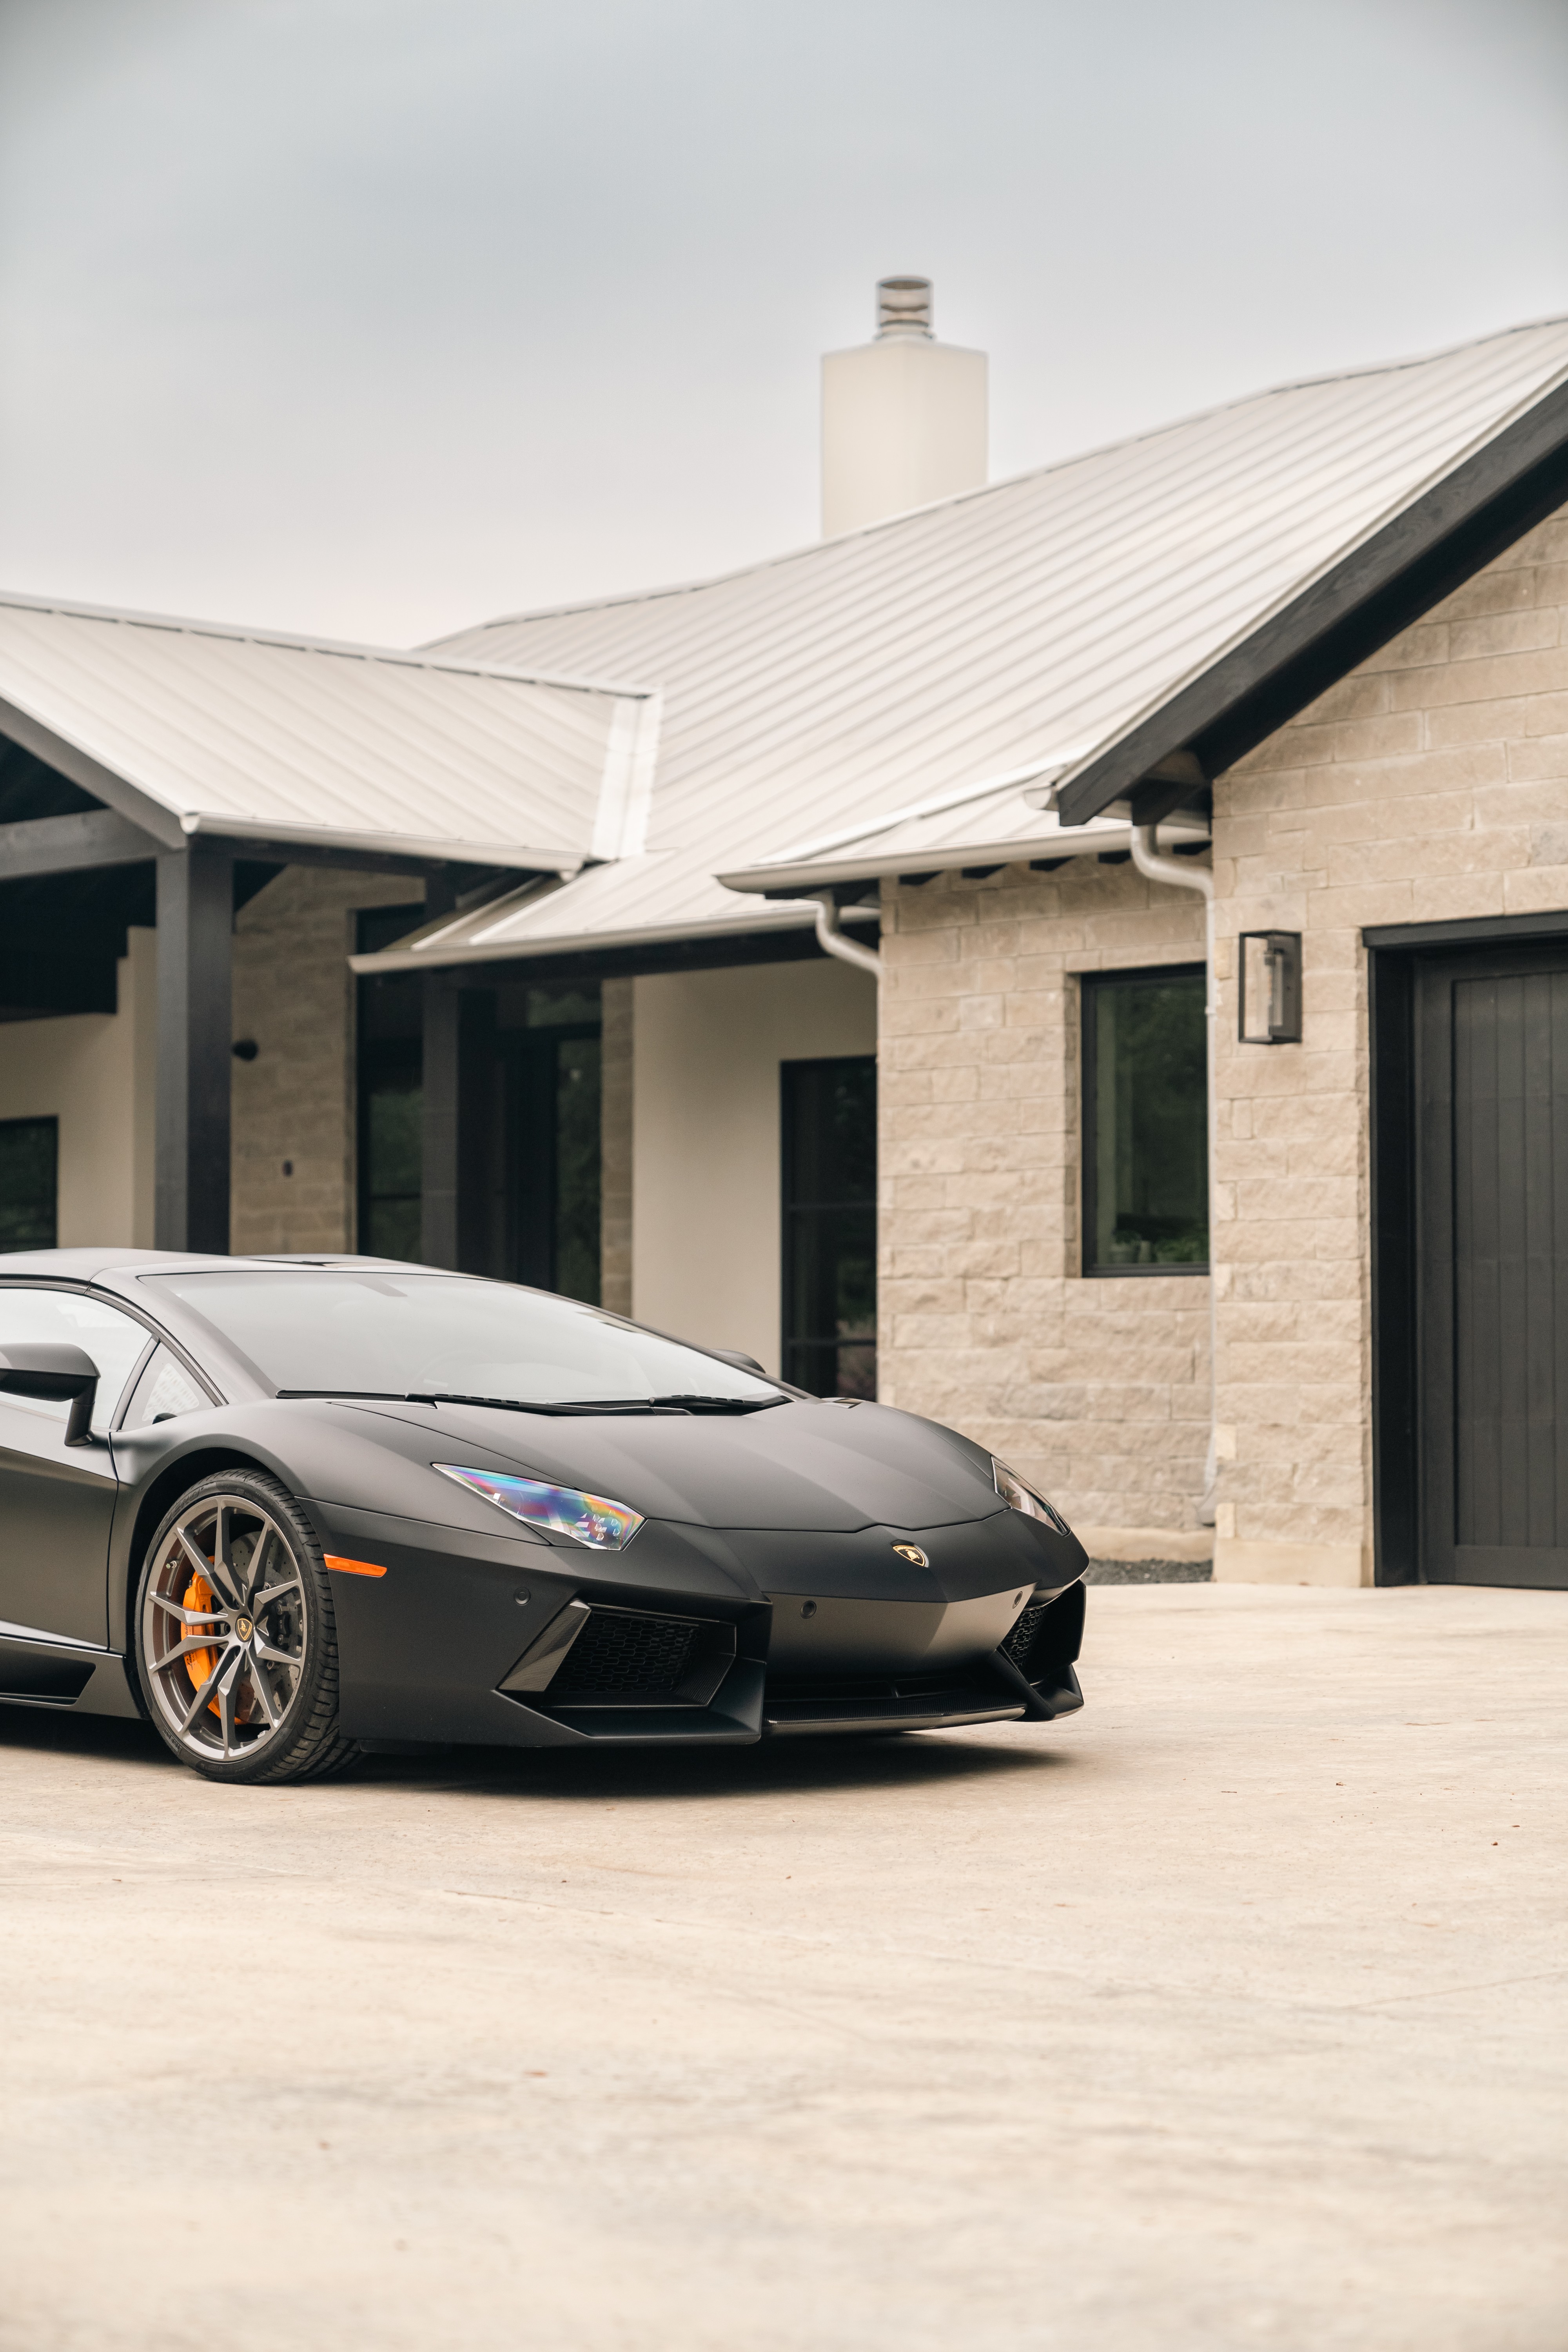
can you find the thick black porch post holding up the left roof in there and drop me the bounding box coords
[155,844,235,1256]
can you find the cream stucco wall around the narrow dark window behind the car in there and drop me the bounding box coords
[632,960,877,1371]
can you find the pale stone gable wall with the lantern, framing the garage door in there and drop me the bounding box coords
[1215,515,1568,1583]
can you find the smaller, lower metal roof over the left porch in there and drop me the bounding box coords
[0,597,658,873]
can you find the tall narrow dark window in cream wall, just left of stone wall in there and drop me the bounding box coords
[783,1054,877,1397]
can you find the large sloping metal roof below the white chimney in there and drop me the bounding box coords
[376,320,1568,964]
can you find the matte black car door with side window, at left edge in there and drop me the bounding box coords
[0,1282,153,1646]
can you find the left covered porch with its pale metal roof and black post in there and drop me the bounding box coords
[0,600,639,1263]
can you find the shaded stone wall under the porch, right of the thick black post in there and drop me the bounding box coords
[230,866,421,1254]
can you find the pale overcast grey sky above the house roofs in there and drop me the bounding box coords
[0,0,1568,642]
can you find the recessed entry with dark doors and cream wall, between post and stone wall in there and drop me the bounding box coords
[355,910,877,1395]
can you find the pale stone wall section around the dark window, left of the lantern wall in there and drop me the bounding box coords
[877,858,1208,1557]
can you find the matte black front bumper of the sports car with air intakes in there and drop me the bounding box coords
[308,1505,1084,1748]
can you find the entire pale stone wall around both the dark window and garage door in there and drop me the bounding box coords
[879,513,1568,1583]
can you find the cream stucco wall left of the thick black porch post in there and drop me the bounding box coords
[0,931,158,1249]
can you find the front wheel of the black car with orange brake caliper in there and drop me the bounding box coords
[132,1470,360,1788]
